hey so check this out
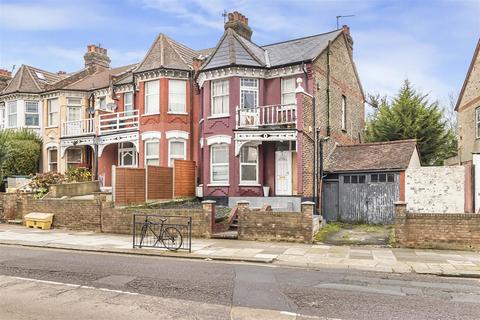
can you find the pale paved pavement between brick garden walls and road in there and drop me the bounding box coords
[0,224,480,278]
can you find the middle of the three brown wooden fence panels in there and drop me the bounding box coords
[147,166,173,200]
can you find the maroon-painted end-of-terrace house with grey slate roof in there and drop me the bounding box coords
[197,12,364,211]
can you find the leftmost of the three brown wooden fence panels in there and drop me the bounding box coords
[114,167,146,205]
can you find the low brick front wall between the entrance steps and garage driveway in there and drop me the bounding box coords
[237,202,314,243]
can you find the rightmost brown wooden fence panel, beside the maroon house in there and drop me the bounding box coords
[173,160,195,198]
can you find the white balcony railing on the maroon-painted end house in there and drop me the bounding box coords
[236,104,297,128]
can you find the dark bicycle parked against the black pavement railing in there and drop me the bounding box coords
[139,216,183,251]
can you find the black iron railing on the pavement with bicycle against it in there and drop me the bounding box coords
[133,213,192,252]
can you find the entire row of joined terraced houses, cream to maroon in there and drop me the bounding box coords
[0,12,364,211]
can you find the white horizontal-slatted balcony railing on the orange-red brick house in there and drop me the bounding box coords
[98,110,139,135]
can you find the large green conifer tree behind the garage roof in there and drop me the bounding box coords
[366,80,457,165]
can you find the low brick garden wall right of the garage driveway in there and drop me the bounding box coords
[395,202,480,250]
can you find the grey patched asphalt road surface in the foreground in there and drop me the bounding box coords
[0,246,480,320]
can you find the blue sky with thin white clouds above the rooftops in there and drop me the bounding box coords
[0,0,480,106]
